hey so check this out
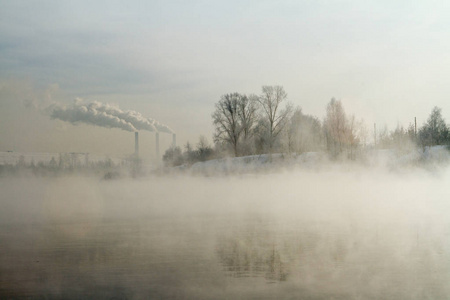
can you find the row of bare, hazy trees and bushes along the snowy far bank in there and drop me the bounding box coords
[163,86,450,166]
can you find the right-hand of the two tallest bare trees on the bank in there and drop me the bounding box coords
[257,85,292,152]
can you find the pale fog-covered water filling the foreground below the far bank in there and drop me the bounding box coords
[0,164,450,299]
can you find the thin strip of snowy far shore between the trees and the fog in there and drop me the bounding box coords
[0,146,450,175]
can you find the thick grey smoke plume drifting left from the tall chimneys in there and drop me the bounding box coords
[49,99,173,133]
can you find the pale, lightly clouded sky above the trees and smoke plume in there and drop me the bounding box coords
[0,0,450,155]
